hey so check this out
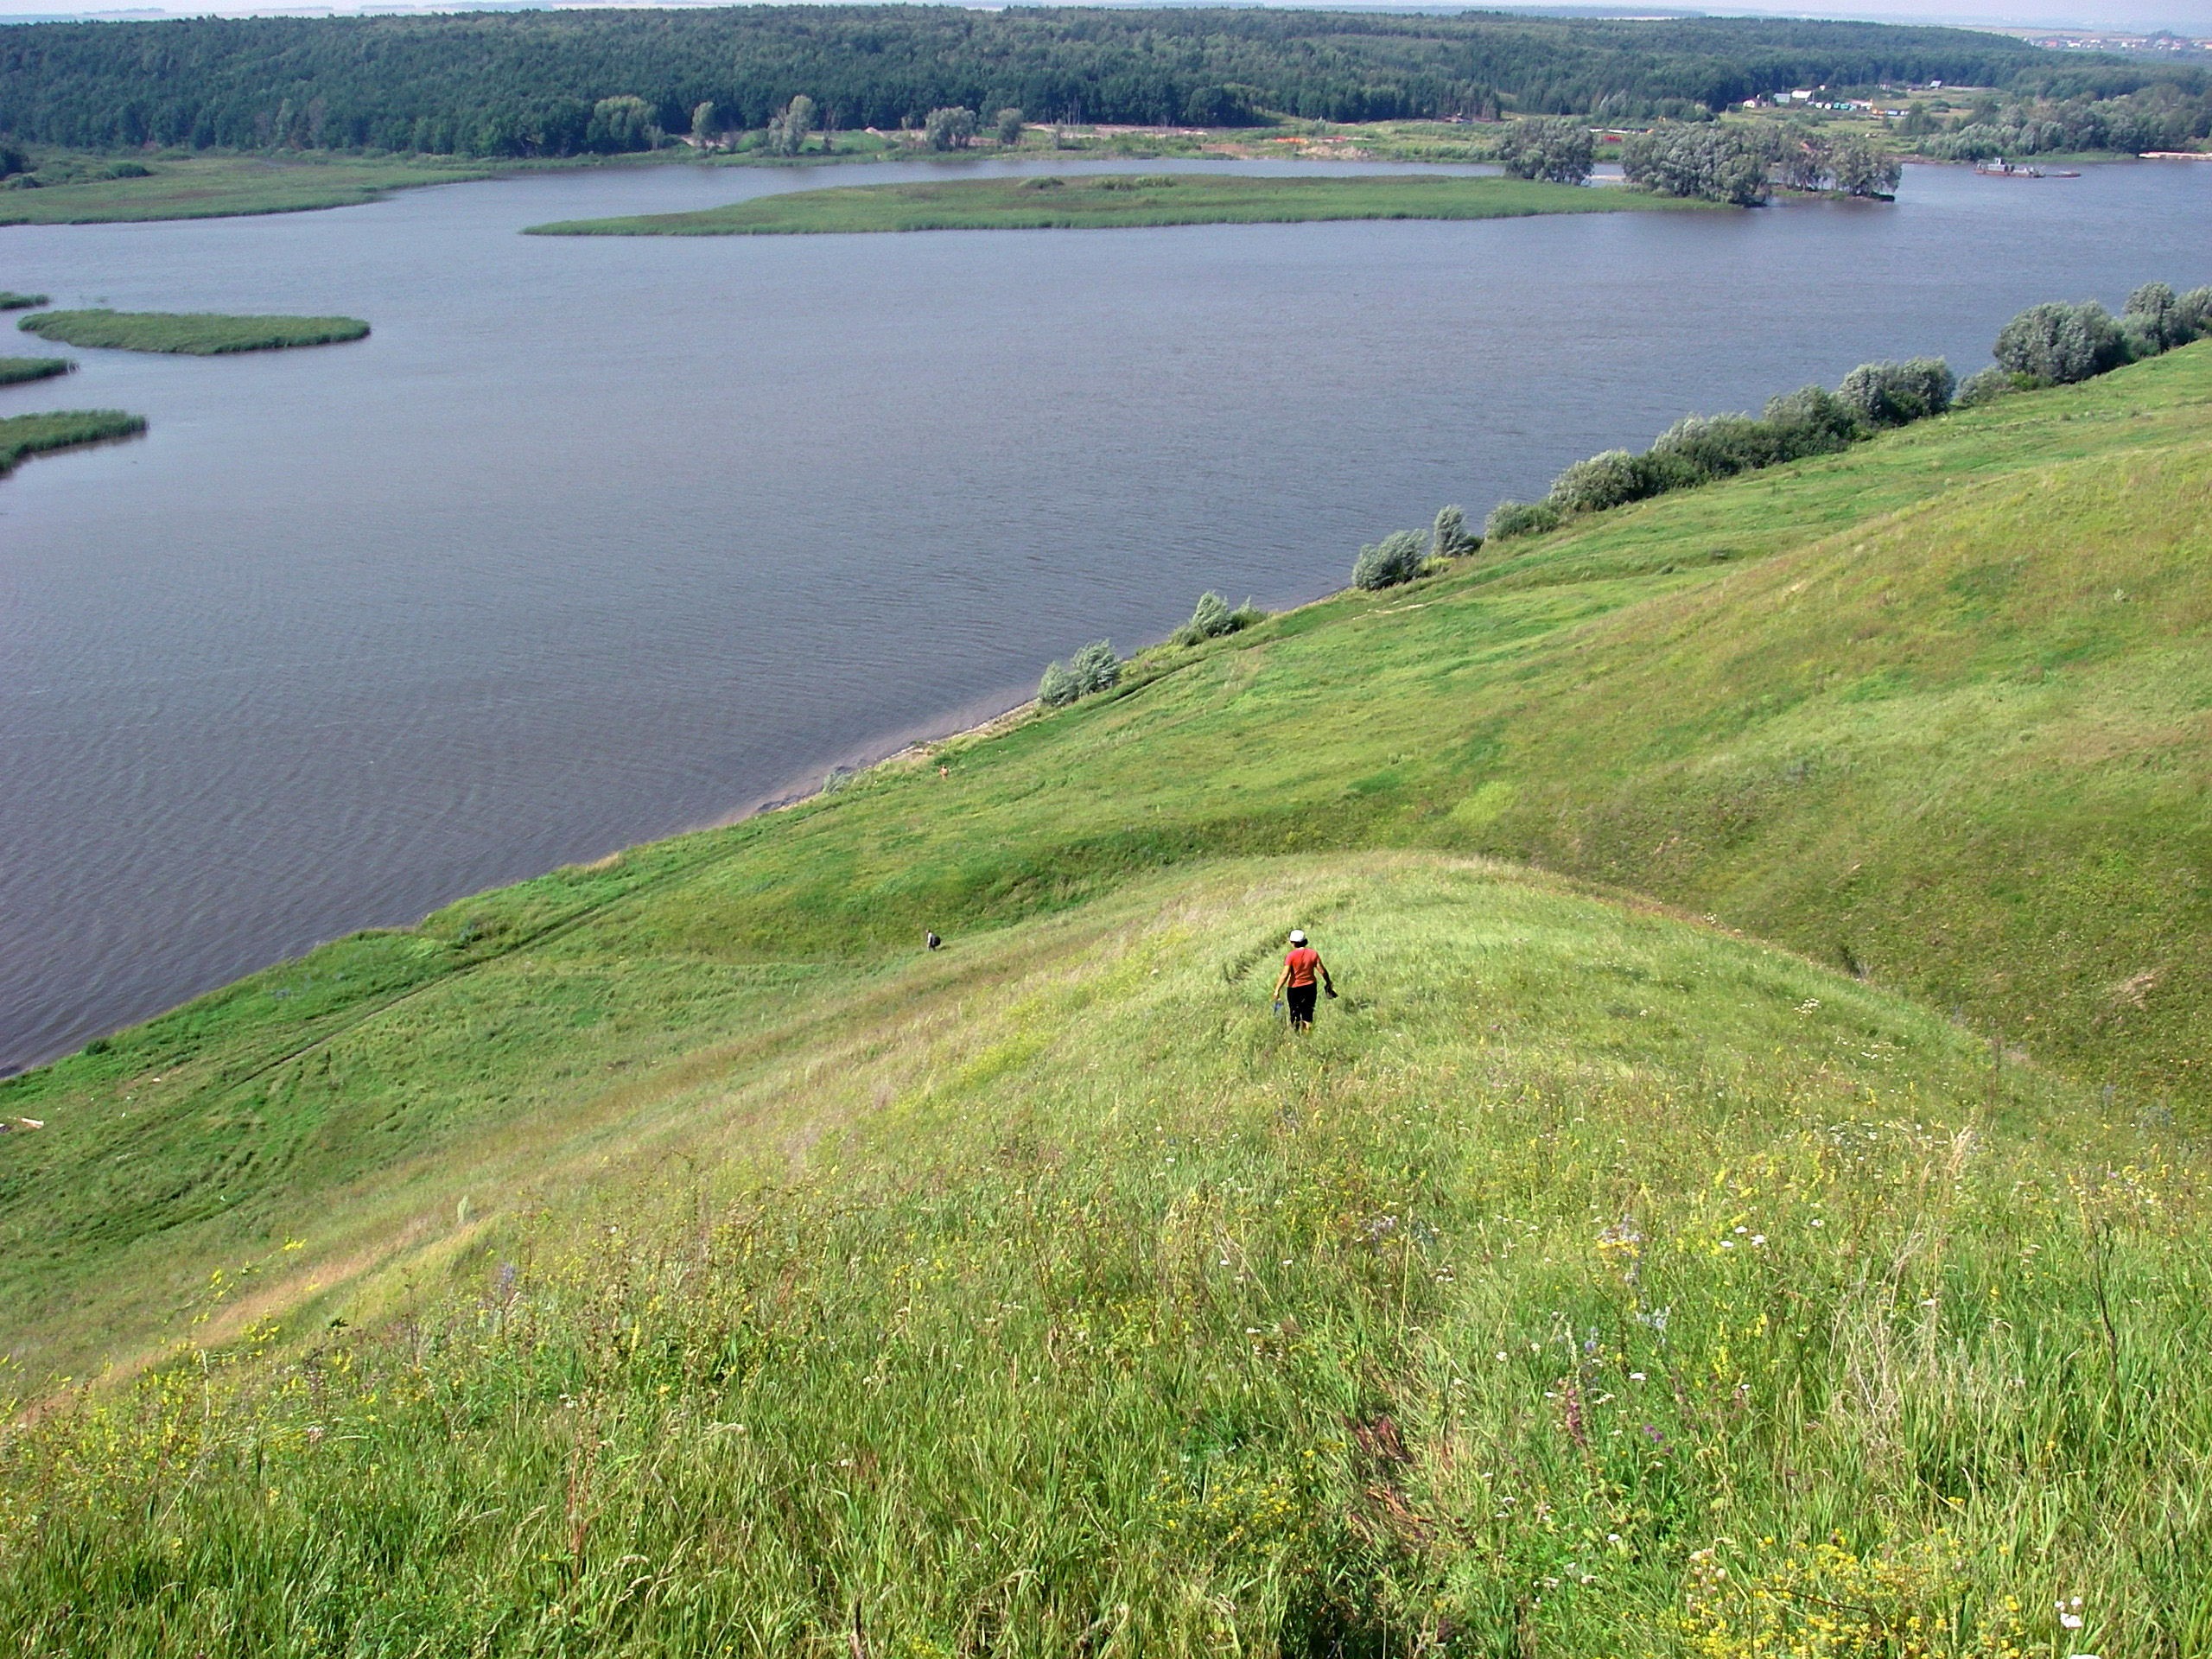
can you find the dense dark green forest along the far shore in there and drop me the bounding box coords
[0,4,2088,155]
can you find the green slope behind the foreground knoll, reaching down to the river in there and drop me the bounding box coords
[0,347,2212,1407]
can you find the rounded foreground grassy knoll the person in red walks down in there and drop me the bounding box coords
[0,854,2212,1659]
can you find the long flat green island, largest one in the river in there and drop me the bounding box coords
[531,173,1712,237]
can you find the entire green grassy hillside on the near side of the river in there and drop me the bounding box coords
[0,345,2212,1659]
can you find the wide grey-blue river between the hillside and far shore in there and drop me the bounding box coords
[0,152,2212,1073]
